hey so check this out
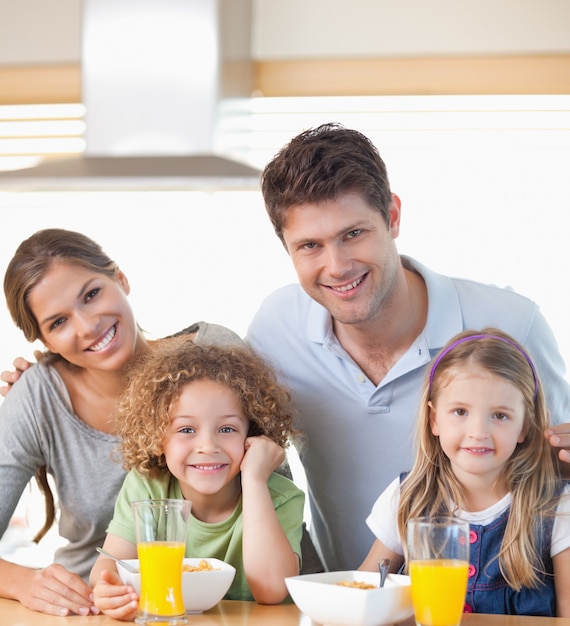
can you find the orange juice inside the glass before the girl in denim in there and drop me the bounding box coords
[410,559,469,626]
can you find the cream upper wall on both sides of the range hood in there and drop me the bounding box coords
[0,0,570,65]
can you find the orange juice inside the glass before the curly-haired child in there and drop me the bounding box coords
[137,541,186,617]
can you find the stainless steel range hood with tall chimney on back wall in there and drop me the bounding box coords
[0,0,260,190]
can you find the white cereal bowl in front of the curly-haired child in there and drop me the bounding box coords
[117,558,236,613]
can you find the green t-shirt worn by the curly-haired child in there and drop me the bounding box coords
[107,470,305,600]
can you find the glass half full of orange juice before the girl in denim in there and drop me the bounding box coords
[408,517,469,626]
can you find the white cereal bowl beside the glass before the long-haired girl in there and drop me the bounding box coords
[285,571,414,626]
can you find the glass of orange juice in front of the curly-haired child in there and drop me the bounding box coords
[131,499,191,626]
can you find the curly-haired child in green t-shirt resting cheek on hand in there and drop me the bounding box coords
[90,338,304,620]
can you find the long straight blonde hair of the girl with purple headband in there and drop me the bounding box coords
[398,328,558,591]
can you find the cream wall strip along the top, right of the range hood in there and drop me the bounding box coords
[252,0,570,59]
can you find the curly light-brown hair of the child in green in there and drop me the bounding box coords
[115,337,297,476]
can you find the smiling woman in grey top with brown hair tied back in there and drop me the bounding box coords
[0,229,160,614]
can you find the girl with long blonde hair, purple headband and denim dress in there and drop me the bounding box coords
[361,328,570,617]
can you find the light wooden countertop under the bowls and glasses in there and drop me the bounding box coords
[0,599,570,626]
